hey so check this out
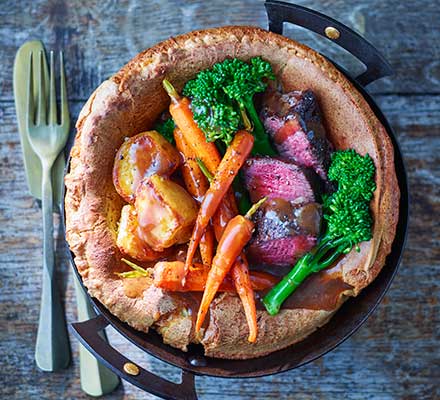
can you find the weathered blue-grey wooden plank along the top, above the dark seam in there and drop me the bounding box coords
[0,0,440,100]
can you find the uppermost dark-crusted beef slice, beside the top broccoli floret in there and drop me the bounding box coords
[261,90,332,180]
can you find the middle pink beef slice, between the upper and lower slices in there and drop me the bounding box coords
[243,157,323,204]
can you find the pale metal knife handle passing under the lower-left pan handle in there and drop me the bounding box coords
[73,273,119,397]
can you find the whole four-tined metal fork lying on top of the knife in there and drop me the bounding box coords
[26,52,70,371]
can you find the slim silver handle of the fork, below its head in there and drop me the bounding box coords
[35,164,70,372]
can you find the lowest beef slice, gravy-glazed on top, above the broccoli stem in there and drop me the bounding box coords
[247,199,321,266]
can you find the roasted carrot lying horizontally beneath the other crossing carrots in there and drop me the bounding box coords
[151,261,279,290]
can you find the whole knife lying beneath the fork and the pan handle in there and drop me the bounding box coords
[13,40,119,397]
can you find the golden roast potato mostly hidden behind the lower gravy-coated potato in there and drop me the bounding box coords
[116,204,165,261]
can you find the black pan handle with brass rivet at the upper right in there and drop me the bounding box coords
[264,0,393,86]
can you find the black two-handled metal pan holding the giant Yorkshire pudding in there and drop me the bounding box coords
[63,1,408,399]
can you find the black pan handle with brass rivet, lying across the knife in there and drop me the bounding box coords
[71,315,197,400]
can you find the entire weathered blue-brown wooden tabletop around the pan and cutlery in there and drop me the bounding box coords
[0,0,440,400]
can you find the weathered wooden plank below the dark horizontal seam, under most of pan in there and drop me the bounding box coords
[0,95,440,400]
